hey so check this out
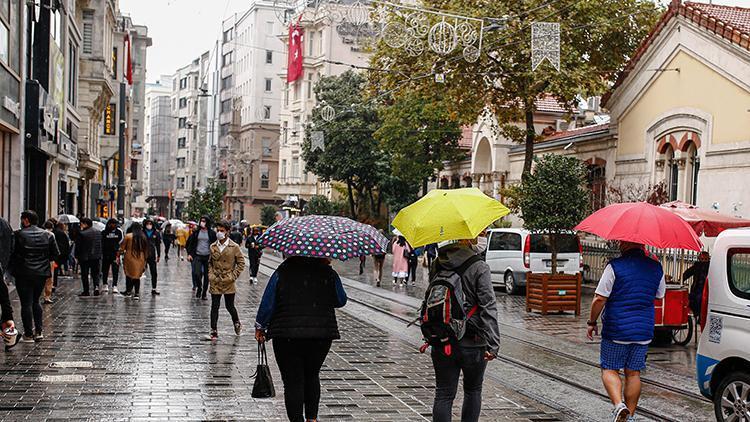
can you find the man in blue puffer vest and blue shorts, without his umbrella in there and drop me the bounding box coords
[587,241,666,422]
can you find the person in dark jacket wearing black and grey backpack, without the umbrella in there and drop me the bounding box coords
[420,239,500,422]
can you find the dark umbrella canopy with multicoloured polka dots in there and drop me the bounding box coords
[258,215,388,261]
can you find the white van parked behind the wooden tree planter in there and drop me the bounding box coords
[485,229,583,294]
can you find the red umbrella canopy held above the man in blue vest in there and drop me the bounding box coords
[575,202,701,251]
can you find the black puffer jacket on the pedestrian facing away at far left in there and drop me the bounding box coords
[8,226,60,278]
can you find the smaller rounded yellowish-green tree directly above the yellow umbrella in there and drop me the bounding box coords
[375,91,462,195]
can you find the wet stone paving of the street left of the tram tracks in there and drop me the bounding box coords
[0,252,568,421]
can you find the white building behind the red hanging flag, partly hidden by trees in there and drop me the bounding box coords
[276,6,368,202]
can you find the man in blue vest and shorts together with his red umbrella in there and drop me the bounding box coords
[575,202,701,422]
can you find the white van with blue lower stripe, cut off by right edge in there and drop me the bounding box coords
[696,229,750,422]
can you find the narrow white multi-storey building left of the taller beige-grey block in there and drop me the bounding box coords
[169,51,210,218]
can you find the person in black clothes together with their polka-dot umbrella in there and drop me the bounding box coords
[255,215,387,422]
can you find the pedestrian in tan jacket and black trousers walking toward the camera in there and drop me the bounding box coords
[208,221,245,341]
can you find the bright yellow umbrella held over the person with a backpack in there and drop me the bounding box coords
[393,188,510,247]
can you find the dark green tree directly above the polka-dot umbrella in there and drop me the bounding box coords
[302,71,387,218]
